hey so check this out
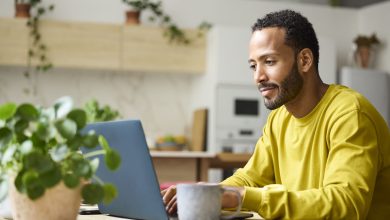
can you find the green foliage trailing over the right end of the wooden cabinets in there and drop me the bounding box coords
[122,0,211,44]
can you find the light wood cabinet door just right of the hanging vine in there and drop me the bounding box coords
[42,21,121,69]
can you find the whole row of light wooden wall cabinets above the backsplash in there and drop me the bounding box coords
[0,18,206,74]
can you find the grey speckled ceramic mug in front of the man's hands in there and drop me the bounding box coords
[176,183,241,220]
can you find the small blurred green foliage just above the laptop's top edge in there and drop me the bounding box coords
[84,99,120,122]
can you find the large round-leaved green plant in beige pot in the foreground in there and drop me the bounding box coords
[0,97,120,219]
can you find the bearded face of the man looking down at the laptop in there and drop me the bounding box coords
[249,27,303,110]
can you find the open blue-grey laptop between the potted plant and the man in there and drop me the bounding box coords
[82,120,252,220]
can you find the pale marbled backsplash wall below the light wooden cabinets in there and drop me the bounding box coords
[0,67,191,146]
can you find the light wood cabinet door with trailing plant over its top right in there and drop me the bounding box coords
[123,25,206,73]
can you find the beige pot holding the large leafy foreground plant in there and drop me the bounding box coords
[9,180,82,220]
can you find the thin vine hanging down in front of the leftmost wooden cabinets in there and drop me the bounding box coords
[25,0,54,77]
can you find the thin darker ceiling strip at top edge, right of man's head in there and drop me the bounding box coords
[258,0,390,8]
